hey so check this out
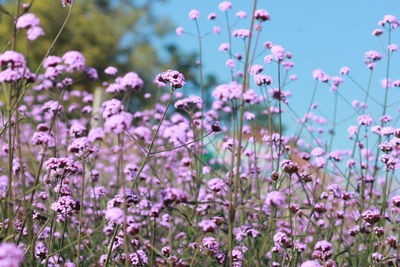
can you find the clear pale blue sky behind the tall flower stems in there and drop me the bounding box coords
[156,0,400,151]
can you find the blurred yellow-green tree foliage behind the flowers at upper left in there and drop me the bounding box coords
[0,0,214,107]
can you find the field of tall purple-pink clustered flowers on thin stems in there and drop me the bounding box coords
[0,0,400,267]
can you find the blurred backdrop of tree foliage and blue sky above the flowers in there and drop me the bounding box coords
[0,0,400,148]
